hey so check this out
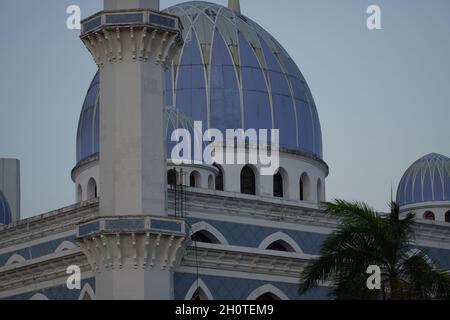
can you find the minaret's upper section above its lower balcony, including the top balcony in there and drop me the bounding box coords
[81,0,182,216]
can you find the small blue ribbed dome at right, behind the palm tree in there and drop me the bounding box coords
[397,153,450,206]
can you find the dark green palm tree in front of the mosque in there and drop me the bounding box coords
[299,200,450,300]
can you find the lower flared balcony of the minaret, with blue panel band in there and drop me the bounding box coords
[77,216,188,273]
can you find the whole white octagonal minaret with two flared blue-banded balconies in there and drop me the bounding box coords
[78,0,186,300]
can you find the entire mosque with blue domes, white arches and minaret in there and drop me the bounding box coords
[0,0,450,300]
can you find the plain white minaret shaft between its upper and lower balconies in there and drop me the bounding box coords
[99,50,166,216]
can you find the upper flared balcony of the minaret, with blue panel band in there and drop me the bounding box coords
[81,9,183,68]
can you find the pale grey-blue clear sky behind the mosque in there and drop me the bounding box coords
[0,0,450,218]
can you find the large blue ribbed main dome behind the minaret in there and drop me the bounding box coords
[77,1,322,162]
